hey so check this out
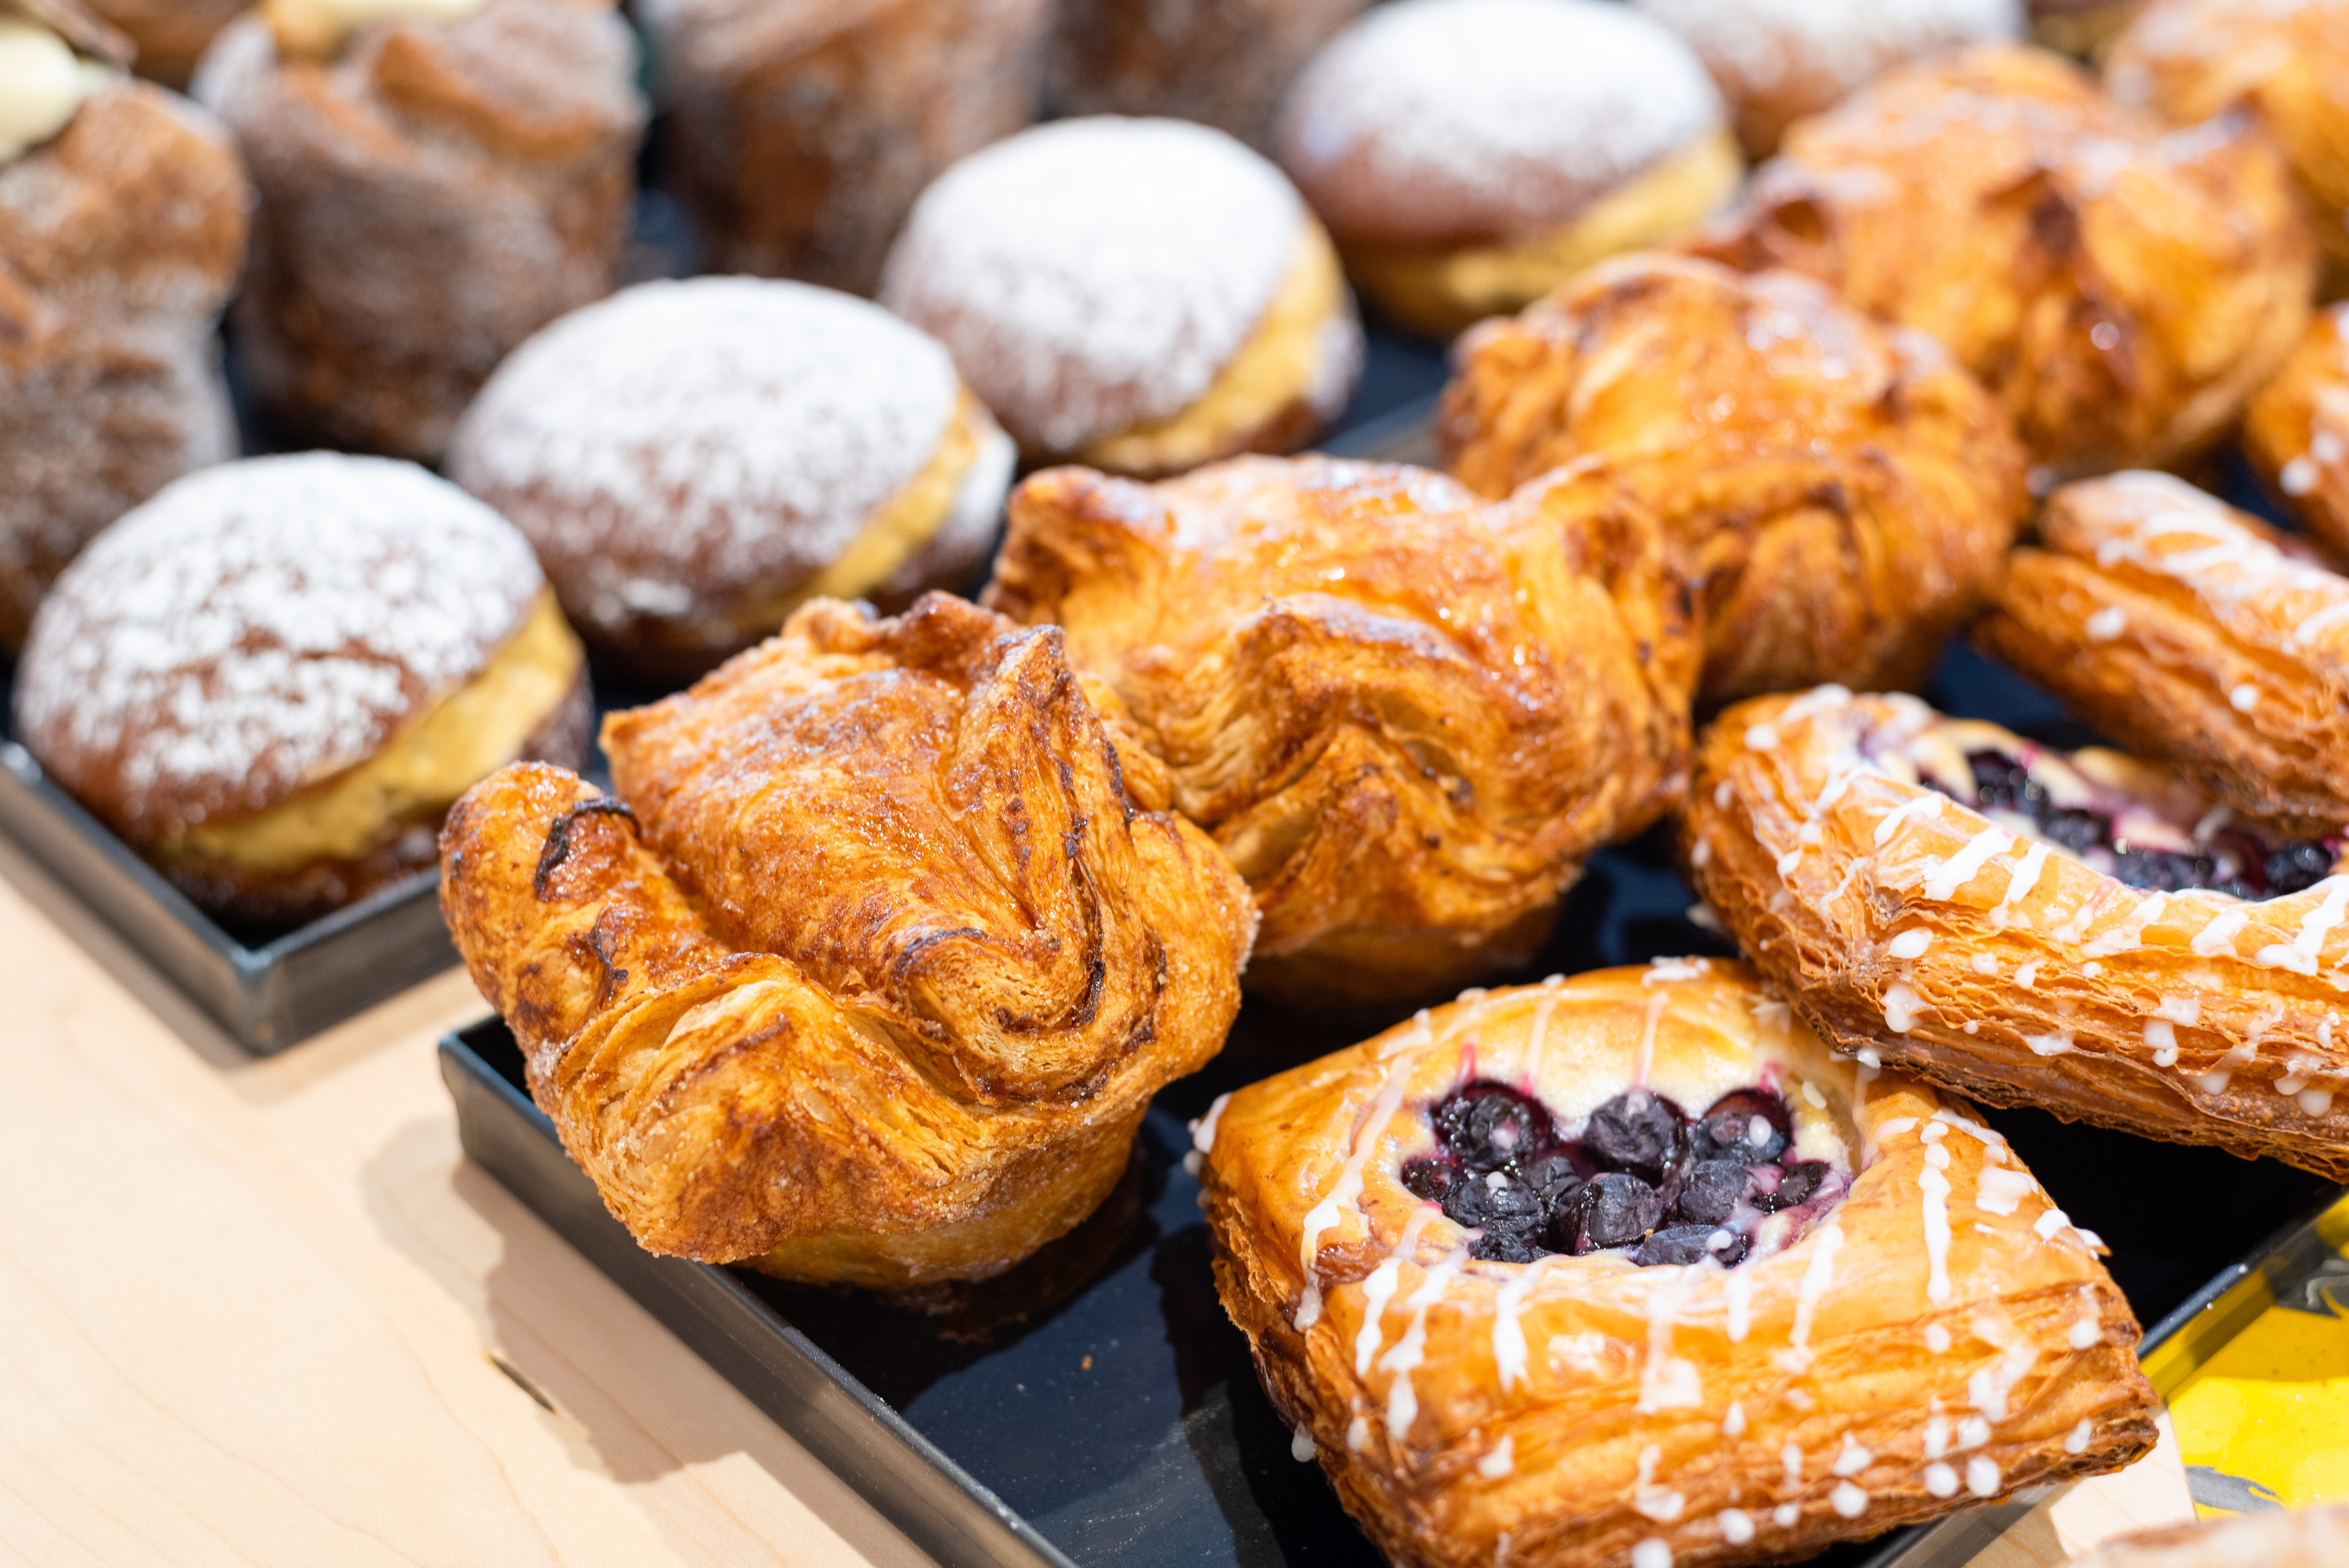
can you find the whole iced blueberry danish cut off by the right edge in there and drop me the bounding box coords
[1682,686,2349,1181]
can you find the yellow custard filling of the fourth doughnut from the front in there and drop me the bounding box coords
[1346,132,1745,333]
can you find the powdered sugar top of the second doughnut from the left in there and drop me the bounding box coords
[449,277,961,627]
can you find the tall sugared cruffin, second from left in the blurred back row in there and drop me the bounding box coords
[195,0,646,460]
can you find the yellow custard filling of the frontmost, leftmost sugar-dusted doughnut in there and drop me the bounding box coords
[157,589,583,871]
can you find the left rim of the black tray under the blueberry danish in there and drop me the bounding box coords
[439,1018,1076,1568]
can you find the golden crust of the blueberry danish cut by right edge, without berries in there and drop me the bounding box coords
[1682,697,2349,1181]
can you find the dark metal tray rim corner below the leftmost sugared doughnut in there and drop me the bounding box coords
[0,742,456,1056]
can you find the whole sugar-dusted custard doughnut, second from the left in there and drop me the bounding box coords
[449,277,1015,679]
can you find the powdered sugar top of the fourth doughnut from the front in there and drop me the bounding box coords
[1280,0,1722,242]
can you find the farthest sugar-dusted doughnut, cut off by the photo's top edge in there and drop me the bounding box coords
[1633,0,2022,157]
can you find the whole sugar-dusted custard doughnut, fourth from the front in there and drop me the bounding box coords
[1278,0,1743,336]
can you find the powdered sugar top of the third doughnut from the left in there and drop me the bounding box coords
[881,115,1304,451]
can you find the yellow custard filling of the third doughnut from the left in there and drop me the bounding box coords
[1071,218,1346,474]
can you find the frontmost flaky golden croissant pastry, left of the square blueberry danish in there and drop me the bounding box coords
[442,594,1254,1286]
